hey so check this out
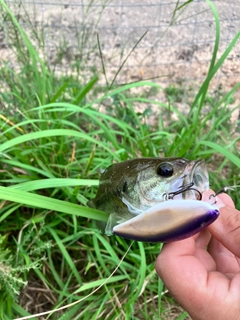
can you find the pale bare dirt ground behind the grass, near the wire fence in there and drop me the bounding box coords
[0,0,240,115]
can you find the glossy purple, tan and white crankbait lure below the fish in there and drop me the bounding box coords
[113,200,219,242]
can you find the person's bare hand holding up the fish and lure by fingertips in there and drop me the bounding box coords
[156,191,240,320]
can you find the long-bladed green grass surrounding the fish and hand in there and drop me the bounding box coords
[0,1,240,320]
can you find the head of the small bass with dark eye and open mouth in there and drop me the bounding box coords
[122,158,209,214]
